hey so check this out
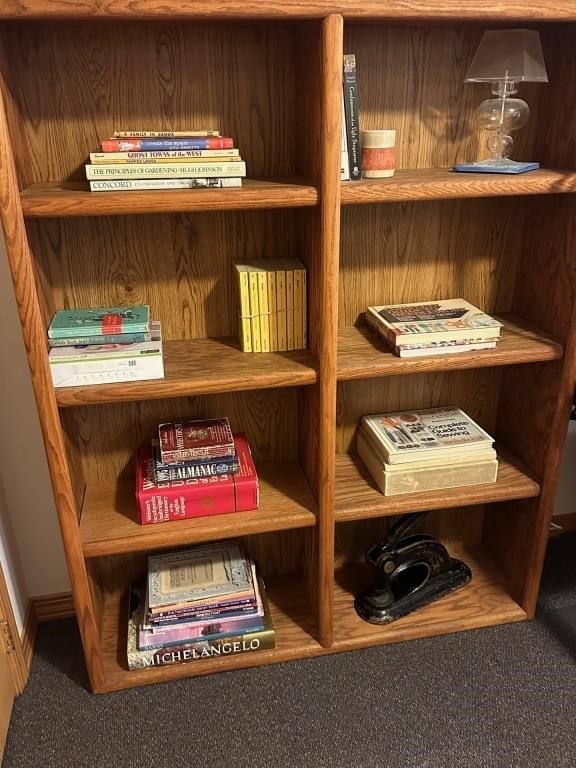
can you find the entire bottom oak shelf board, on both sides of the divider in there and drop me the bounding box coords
[96,547,527,693]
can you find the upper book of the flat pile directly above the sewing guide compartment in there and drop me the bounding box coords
[366,299,502,347]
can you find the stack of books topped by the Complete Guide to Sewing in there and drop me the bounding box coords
[356,406,498,496]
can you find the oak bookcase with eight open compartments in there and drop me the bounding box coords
[0,0,576,692]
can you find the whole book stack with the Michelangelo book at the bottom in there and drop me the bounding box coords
[127,541,275,669]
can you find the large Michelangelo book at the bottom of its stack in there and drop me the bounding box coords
[126,579,275,669]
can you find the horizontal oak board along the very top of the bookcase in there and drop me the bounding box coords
[0,0,576,22]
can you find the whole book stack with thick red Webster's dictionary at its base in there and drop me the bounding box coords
[136,418,260,525]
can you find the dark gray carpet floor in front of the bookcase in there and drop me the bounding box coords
[2,535,576,768]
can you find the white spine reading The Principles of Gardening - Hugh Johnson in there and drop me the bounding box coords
[85,160,246,181]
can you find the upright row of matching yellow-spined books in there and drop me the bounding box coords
[234,259,308,352]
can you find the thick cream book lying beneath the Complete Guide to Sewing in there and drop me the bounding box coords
[356,430,498,496]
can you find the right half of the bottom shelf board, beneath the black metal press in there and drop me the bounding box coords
[334,546,527,651]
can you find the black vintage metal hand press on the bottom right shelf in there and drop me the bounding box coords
[354,512,472,624]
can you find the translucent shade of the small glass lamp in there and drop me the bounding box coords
[464,29,548,83]
